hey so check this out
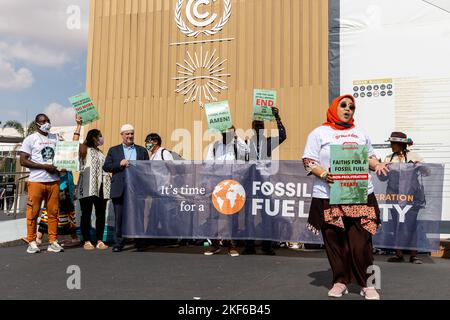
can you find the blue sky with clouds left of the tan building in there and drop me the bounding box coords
[0,0,89,126]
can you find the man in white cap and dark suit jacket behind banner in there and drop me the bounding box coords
[103,124,149,252]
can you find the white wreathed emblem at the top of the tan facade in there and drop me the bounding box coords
[175,0,231,37]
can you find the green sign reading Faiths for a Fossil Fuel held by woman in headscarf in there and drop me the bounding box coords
[330,145,369,204]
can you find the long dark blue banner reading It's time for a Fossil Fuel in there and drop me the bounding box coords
[122,161,444,251]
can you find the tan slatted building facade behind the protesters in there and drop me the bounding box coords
[86,0,328,160]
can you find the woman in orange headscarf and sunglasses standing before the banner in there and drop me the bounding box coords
[302,95,387,300]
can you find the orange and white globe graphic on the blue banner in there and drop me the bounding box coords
[212,180,246,215]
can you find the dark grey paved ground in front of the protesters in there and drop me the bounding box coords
[0,242,450,300]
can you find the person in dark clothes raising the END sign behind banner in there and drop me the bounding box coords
[242,108,287,255]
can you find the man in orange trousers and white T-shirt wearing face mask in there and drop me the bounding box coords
[20,114,63,253]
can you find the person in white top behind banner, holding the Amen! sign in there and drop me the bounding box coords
[204,126,249,257]
